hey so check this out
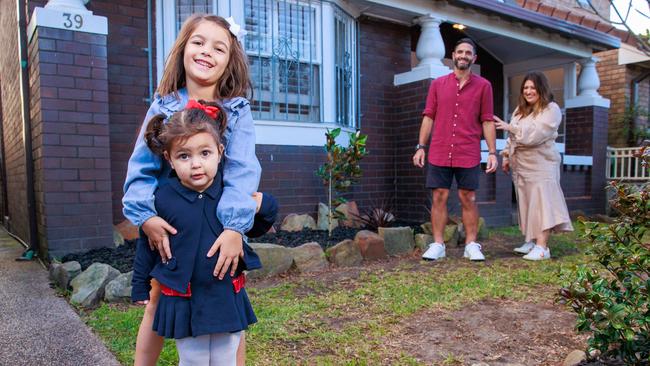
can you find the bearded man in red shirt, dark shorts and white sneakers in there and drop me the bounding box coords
[413,38,498,261]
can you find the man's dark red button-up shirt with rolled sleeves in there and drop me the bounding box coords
[422,72,494,168]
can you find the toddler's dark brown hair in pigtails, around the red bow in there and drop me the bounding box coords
[144,100,227,155]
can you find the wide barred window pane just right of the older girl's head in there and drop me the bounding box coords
[244,0,321,122]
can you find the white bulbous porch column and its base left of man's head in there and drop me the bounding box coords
[393,14,451,85]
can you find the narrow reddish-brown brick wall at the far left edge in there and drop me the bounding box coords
[0,1,29,241]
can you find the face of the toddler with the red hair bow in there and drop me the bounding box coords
[165,132,222,192]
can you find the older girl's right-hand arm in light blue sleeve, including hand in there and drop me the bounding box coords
[208,101,262,279]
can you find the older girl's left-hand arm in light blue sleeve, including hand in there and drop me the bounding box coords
[122,97,176,258]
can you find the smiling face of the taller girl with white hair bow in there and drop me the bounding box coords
[183,20,231,91]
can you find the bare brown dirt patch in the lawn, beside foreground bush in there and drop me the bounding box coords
[392,300,587,366]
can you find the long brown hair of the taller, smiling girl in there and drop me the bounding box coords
[156,14,252,99]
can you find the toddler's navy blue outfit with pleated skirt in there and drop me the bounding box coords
[132,174,277,339]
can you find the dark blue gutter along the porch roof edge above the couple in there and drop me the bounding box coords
[450,0,621,49]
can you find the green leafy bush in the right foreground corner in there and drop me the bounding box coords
[559,144,650,364]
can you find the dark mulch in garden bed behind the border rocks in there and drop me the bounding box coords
[54,221,422,273]
